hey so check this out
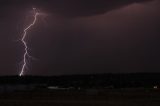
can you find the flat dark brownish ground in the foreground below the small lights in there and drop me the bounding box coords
[0,88,160,106]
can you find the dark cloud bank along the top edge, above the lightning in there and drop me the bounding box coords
[0,0,152,17]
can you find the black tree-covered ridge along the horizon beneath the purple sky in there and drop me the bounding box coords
[0,73,160,88]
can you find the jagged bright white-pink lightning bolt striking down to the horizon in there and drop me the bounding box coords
[19,8,39,76]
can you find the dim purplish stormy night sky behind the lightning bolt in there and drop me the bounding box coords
[0,0,160,75]
